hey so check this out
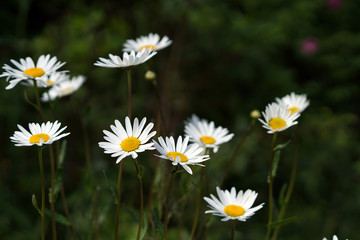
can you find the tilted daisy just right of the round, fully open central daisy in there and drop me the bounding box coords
[153,136,210,174]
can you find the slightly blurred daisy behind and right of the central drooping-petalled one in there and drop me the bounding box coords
[185,114,234,152]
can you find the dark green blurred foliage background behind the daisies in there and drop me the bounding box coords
[0,0,360,240]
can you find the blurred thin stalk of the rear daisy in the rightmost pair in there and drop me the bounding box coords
[271,135,298,240]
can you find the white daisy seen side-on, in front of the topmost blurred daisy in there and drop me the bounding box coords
[94,49,157,68]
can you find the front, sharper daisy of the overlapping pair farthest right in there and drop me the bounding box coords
[259,103,300,134]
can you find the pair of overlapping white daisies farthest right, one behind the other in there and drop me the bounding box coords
[259,92,310,134]
